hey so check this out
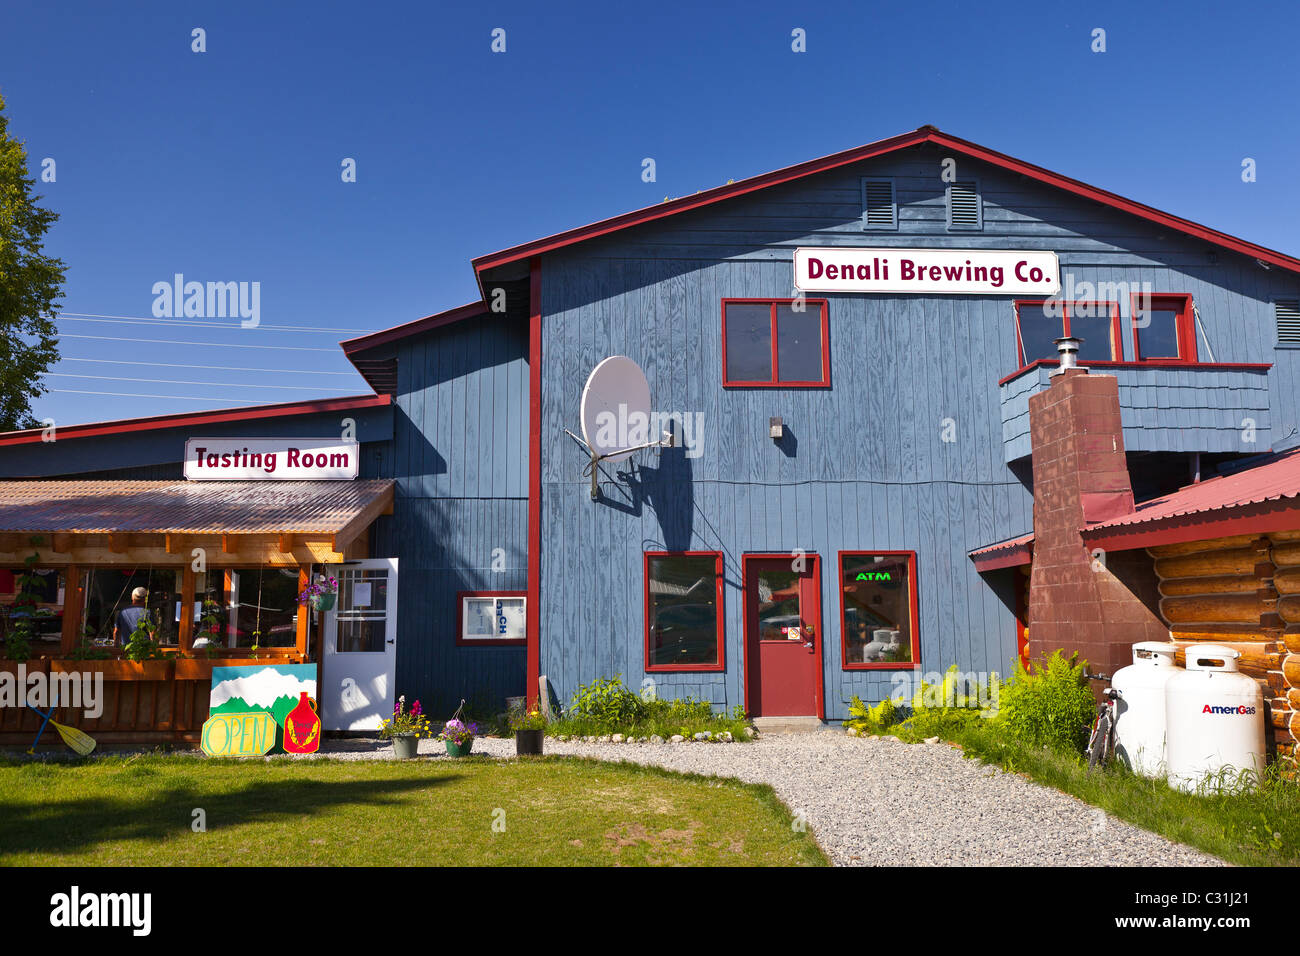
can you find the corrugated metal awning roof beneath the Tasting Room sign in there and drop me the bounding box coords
[0,479,393,535]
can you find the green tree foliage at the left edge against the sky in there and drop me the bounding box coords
[0,96,65,431]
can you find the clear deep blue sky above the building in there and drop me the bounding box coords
[0,0,1300,424]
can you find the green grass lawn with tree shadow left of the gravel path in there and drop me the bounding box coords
[0,756,827,866]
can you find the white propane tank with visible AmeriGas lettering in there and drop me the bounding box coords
[1165,644,1265,792]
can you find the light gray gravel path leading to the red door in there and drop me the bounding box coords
[314,732,1225,866]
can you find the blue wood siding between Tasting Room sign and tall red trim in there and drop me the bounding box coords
[364,316,528,718]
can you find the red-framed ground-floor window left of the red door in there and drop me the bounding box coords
[646,551,723,671]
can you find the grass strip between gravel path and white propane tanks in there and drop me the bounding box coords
[950,722,1300,866]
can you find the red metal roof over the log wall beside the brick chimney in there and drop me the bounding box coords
[1083,447,1300,548]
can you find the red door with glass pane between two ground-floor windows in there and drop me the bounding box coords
[742,554,823,718]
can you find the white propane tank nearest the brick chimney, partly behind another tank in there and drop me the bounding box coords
[1110,641,1178,777]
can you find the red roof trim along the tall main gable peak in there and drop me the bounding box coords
[472,126,1300,281]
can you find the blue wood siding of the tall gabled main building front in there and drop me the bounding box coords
[540,147,1300,719]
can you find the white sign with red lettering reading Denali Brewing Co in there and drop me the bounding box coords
[794,248,1061,295]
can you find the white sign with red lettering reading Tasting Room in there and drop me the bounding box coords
[185,438,361,481]
